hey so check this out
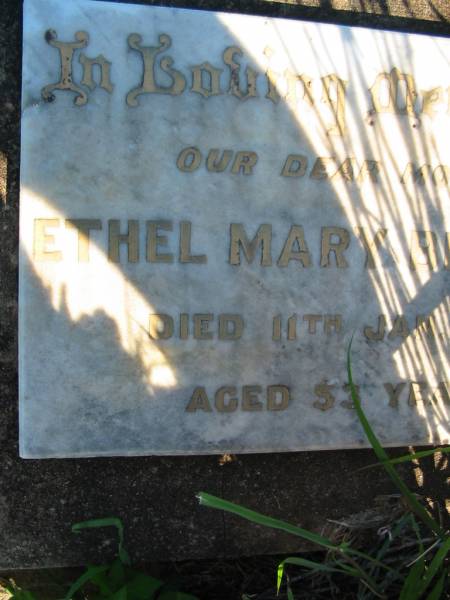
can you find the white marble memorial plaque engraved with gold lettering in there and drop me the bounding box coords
[19,0,450,458]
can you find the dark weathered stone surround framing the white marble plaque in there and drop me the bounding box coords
[0,0,450,569]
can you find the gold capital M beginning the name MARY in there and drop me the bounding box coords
[230,223,272,267]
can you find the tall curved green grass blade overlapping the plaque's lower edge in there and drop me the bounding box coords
[347,337,444,537]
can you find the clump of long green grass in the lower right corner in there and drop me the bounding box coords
[198,342,450,600]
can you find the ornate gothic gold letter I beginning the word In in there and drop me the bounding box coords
[41,29,89,106]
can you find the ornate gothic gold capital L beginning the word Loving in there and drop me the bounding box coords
[126,33,186,106]
